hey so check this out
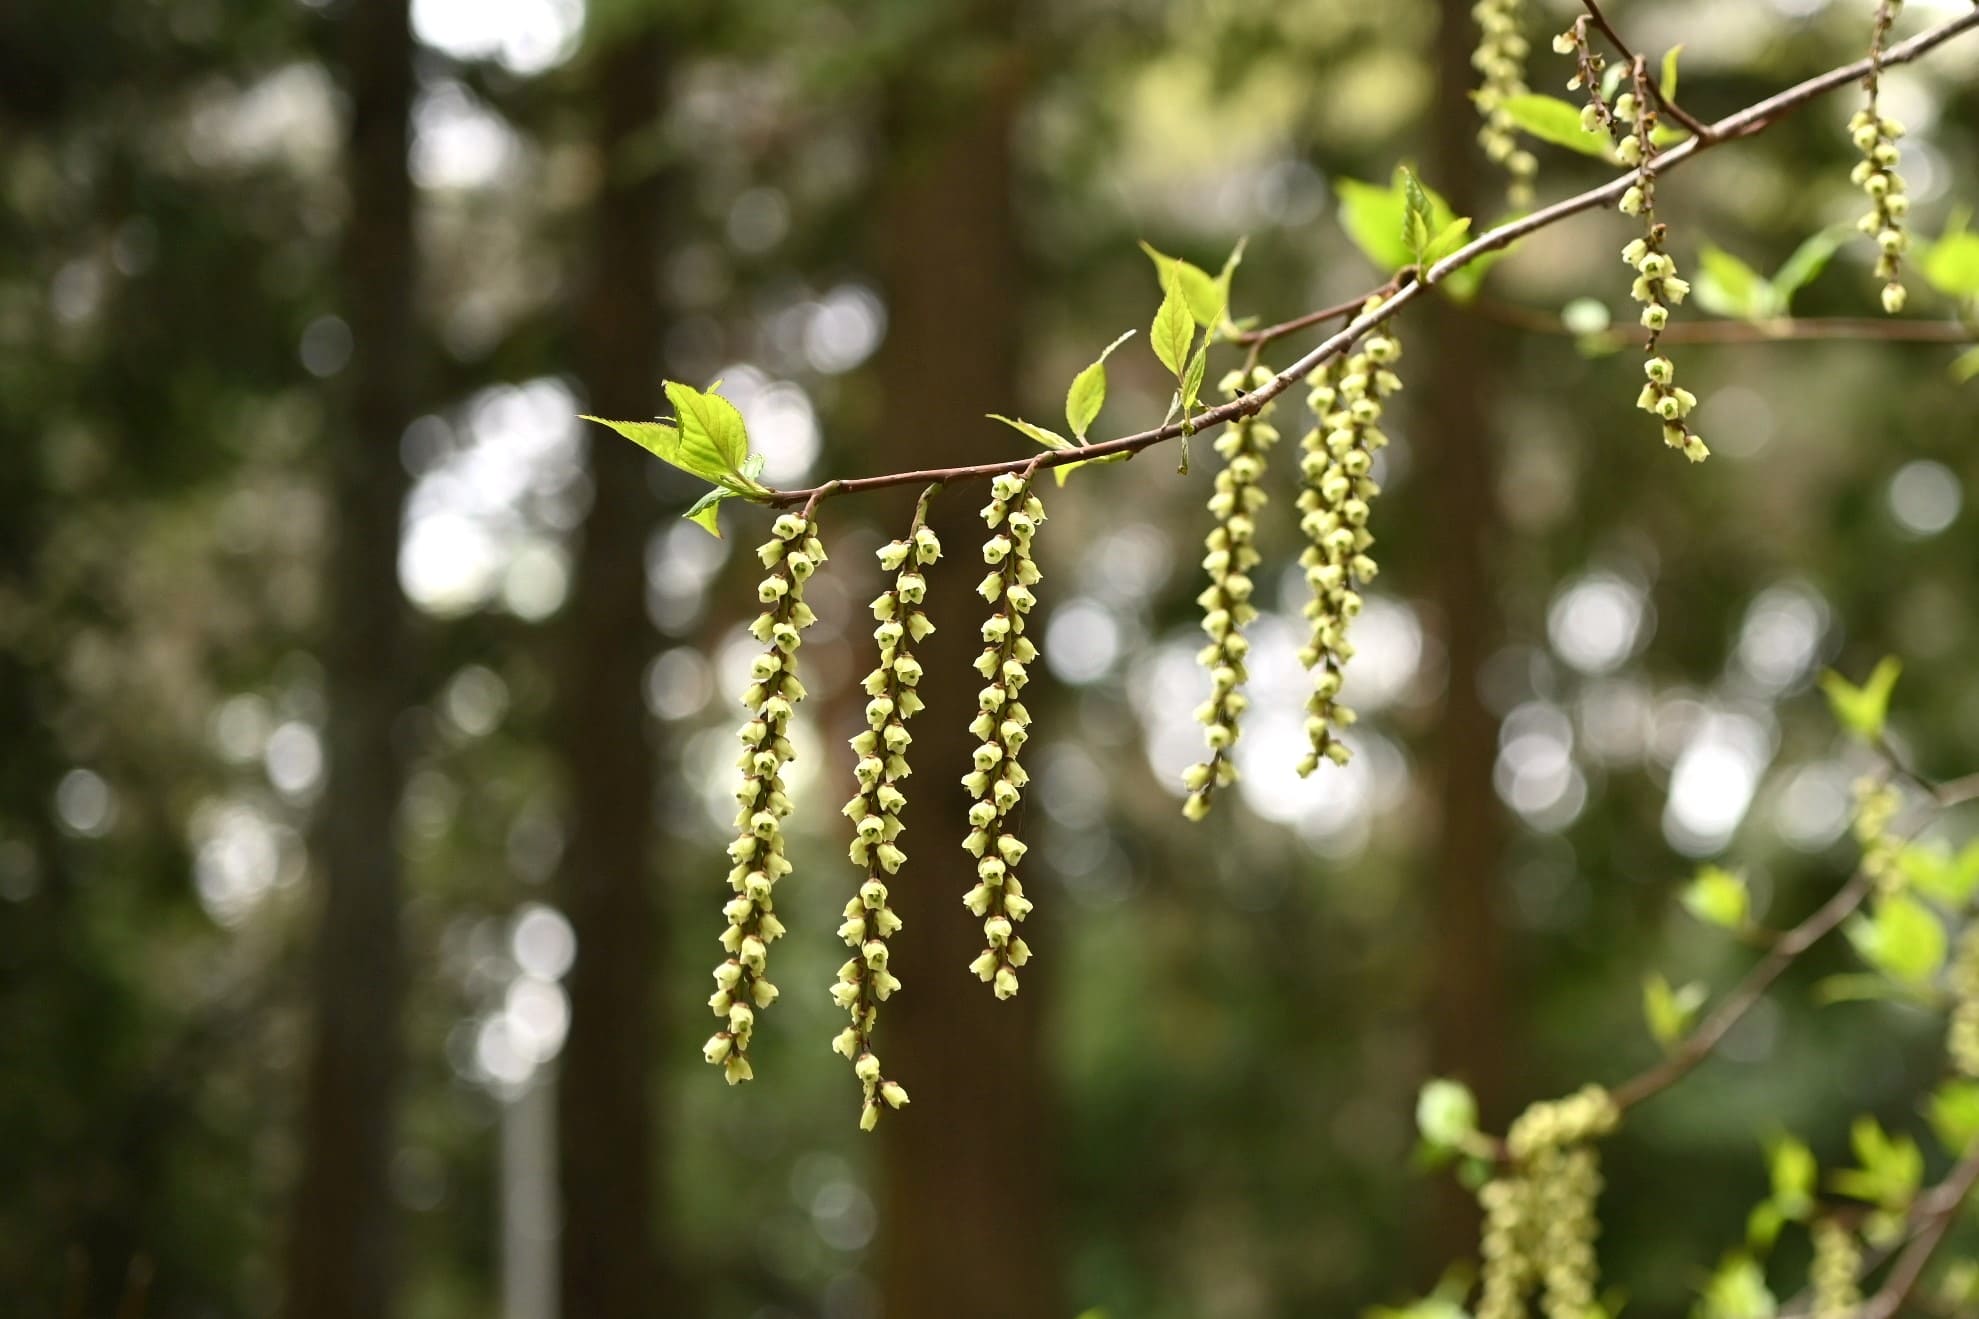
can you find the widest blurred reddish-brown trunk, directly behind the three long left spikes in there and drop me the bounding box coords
[871,6,1061,1319]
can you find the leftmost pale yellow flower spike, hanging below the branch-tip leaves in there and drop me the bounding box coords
[703,509,825,1085]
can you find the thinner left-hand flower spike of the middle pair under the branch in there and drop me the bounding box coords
[1181,366,1278,820]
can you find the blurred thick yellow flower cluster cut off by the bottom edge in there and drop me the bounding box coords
[1476,1085,1621,1319]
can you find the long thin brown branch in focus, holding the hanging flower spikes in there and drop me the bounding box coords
[756,8,1979,507]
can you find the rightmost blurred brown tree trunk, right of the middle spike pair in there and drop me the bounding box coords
[1415,0,1512,1262]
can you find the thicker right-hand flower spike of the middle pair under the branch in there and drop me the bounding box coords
[1298,301,1401,776]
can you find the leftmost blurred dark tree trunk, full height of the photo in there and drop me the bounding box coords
[285,0,416,1319]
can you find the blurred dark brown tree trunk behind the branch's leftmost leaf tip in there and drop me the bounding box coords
[556,22,667,1319]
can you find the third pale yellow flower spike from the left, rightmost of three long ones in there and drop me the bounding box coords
[962,463,1045,998]
